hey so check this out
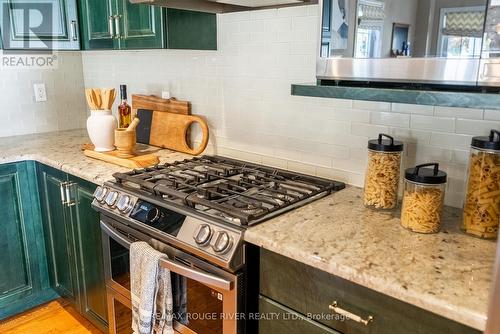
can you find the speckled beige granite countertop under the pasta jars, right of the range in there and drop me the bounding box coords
[245,187,496,330]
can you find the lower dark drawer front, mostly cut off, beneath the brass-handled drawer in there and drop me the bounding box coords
[259,296,340,334]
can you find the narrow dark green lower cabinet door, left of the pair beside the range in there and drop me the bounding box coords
[38,165,78,302]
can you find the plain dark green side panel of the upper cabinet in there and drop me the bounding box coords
[167,8,217,50]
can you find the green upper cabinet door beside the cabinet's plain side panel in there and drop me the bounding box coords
[116,0,166,49]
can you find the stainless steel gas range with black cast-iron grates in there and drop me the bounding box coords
[92,156,345,334]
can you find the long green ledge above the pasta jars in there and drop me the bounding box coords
[292,84,500,110]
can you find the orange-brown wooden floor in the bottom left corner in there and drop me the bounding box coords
[0,299,102,334]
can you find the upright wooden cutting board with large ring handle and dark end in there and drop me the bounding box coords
[137,109,209,155]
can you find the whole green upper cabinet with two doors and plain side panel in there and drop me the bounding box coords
[79,0,217,50]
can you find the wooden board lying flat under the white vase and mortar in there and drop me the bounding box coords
[82,144,160,169]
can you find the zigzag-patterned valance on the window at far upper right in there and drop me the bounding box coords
[442,11,484,38]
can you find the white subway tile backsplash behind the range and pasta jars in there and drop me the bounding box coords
[79,6,500,206]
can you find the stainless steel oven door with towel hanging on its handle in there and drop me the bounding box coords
[101,218,243,334]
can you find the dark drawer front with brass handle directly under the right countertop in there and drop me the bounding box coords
[260,250,479,334]
